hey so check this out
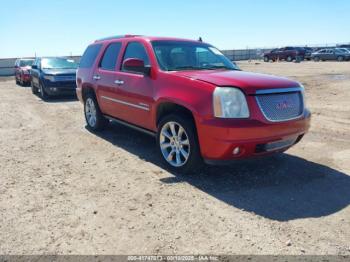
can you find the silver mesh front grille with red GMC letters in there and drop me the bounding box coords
[256,91,304,122]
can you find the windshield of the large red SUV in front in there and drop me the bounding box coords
[152,40,239,71]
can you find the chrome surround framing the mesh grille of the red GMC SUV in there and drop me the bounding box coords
[255,87,305,123]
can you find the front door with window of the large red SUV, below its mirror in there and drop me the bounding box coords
[109,42,153,129]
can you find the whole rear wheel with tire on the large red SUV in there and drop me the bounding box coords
[84,93,109,131]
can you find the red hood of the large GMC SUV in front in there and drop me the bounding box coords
[174,70,300,94]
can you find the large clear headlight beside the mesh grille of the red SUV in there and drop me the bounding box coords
[213,87,249,118]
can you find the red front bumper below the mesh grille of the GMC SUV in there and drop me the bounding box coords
[197,110,311,162]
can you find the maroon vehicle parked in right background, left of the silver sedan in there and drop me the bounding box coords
[264,47,306,62]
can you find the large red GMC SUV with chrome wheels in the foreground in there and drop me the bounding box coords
[76,35,310,172]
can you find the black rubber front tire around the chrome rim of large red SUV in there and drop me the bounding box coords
[157,114,203,174]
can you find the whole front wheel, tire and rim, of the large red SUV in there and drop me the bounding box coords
[157,115,203,174]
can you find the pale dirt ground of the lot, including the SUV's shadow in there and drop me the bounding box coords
[0,62,350,255]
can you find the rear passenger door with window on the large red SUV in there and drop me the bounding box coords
[93,42,122,117]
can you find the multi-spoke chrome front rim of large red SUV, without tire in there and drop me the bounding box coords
[159,122,191,167]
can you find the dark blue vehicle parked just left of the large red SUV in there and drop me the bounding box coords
[31,57,78,99]
